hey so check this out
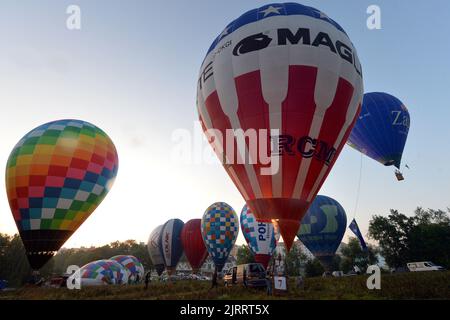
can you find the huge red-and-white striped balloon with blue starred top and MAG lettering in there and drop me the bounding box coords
[197,3,363,250]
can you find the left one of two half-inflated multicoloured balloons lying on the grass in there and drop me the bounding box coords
[79,260,128,287]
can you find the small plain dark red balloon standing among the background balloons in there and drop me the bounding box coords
[181,219,208,273]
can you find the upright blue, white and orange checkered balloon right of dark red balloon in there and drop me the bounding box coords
[202,202,239,272]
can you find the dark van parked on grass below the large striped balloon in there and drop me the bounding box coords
[223,263,267,288]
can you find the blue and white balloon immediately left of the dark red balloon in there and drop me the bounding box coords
[160,219,184,275]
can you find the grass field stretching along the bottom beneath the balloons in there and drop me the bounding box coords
[0,271,450,300]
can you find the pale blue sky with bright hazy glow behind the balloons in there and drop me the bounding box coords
[0,0,450,247]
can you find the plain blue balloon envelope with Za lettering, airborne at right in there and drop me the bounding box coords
[348,92,410,169]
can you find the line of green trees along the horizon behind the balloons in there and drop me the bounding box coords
[0,207,450,287]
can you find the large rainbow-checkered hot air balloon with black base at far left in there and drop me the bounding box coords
[6,120,118,270]
